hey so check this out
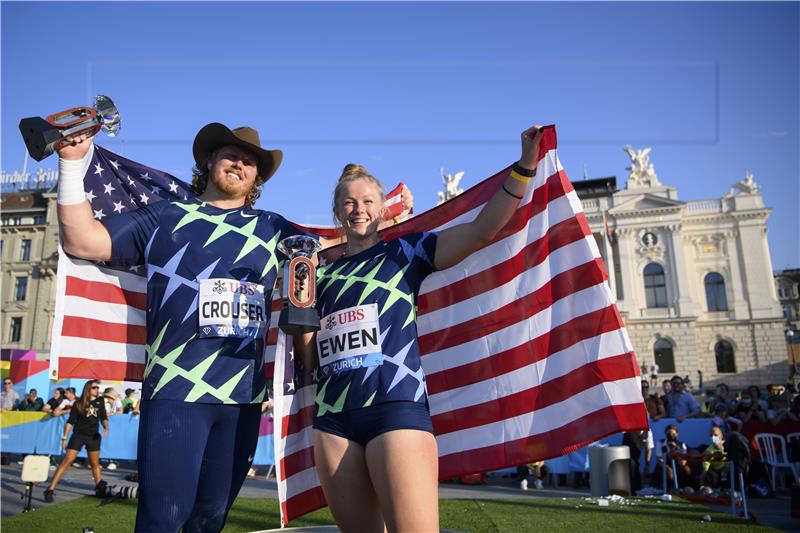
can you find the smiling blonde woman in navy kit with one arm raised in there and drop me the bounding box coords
[295,126,541,532]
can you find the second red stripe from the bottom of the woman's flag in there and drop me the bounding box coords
[432,352,638,435]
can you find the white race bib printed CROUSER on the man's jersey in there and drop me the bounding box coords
[198,278,268,339]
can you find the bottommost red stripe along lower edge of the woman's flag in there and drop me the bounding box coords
[439,403,648,479]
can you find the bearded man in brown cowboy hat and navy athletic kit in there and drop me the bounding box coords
[58,123,310,531]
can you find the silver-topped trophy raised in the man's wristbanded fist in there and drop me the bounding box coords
[19,94,120,161]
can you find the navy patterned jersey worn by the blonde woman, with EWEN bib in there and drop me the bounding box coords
[315,233,437,417]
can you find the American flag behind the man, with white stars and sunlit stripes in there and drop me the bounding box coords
[50,145,194,381]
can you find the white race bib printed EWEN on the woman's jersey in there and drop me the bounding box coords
[317,304,383,375]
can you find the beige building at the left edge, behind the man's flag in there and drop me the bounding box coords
[0,191,58,359]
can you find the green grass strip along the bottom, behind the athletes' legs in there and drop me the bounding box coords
[2,497,775,533]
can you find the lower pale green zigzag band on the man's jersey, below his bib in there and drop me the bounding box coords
[144,320,250,404]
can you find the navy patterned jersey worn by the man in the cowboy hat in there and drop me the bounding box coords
[103,200,303,404]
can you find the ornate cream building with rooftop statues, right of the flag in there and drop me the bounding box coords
[574,147,788,387]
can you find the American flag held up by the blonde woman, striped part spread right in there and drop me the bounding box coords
[275,126,647,524]
